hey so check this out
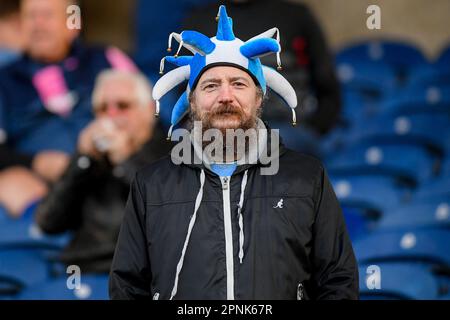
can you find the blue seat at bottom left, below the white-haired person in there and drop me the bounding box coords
[18,274,109,300]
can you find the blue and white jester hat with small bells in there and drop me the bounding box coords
[153,5,297,138]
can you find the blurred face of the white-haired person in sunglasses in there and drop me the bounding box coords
[94,79,154,139]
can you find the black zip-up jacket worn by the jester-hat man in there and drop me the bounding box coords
[110,130,358,300]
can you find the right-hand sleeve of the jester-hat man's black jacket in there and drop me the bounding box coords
[310,169,359,300]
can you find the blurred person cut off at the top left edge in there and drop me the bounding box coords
[0,0,24,68]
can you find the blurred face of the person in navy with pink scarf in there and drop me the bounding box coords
[21,0,78,62]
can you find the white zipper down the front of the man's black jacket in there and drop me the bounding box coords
[220,176,234,300]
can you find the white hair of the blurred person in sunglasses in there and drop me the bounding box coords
[92,69,153,107]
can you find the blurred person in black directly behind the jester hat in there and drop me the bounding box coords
[182,0,341,156]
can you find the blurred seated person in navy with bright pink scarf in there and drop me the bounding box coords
[0,0,134,216]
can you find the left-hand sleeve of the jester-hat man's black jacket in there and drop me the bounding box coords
[109,176,152,300]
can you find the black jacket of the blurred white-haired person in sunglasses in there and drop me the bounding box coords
[35,126,171,273]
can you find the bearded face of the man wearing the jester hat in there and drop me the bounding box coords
[191,66,262,134]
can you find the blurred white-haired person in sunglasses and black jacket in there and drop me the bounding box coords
[35,70,170,272]
